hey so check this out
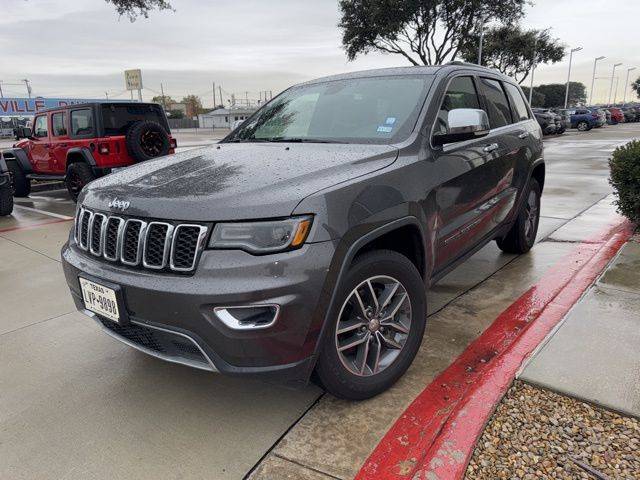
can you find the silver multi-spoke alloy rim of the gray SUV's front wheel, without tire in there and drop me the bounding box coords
[335,275,411,377]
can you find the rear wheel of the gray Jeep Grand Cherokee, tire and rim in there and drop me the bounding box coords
[496,178,541,254]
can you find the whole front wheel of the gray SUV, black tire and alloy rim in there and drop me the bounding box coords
[316,250,427,400]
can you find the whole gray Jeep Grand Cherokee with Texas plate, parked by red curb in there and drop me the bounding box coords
[62,63,545,399]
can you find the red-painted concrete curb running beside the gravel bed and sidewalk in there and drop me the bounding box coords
[355,221,632,480]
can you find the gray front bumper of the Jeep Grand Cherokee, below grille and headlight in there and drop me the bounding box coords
[62,240,334,381]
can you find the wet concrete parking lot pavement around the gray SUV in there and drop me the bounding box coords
[0,125,638,479]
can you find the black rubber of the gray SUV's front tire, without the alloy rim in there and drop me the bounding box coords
[314,250,427,400]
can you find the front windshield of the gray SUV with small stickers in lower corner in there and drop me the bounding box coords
[225,75,433,144]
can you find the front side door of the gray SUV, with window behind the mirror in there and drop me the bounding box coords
[433,74,511,271]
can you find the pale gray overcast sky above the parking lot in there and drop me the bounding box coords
[0,0,640,105]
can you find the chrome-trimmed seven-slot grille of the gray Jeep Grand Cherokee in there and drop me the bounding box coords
[75,208,207,272]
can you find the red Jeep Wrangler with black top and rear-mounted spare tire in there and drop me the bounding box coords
[2,102,176,201]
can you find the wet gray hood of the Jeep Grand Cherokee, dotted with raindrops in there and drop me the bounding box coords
[80,143,398,222]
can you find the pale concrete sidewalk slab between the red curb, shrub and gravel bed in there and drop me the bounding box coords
[519,235,640,417]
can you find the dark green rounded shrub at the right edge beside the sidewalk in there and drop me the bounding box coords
[609,140,640,222]
